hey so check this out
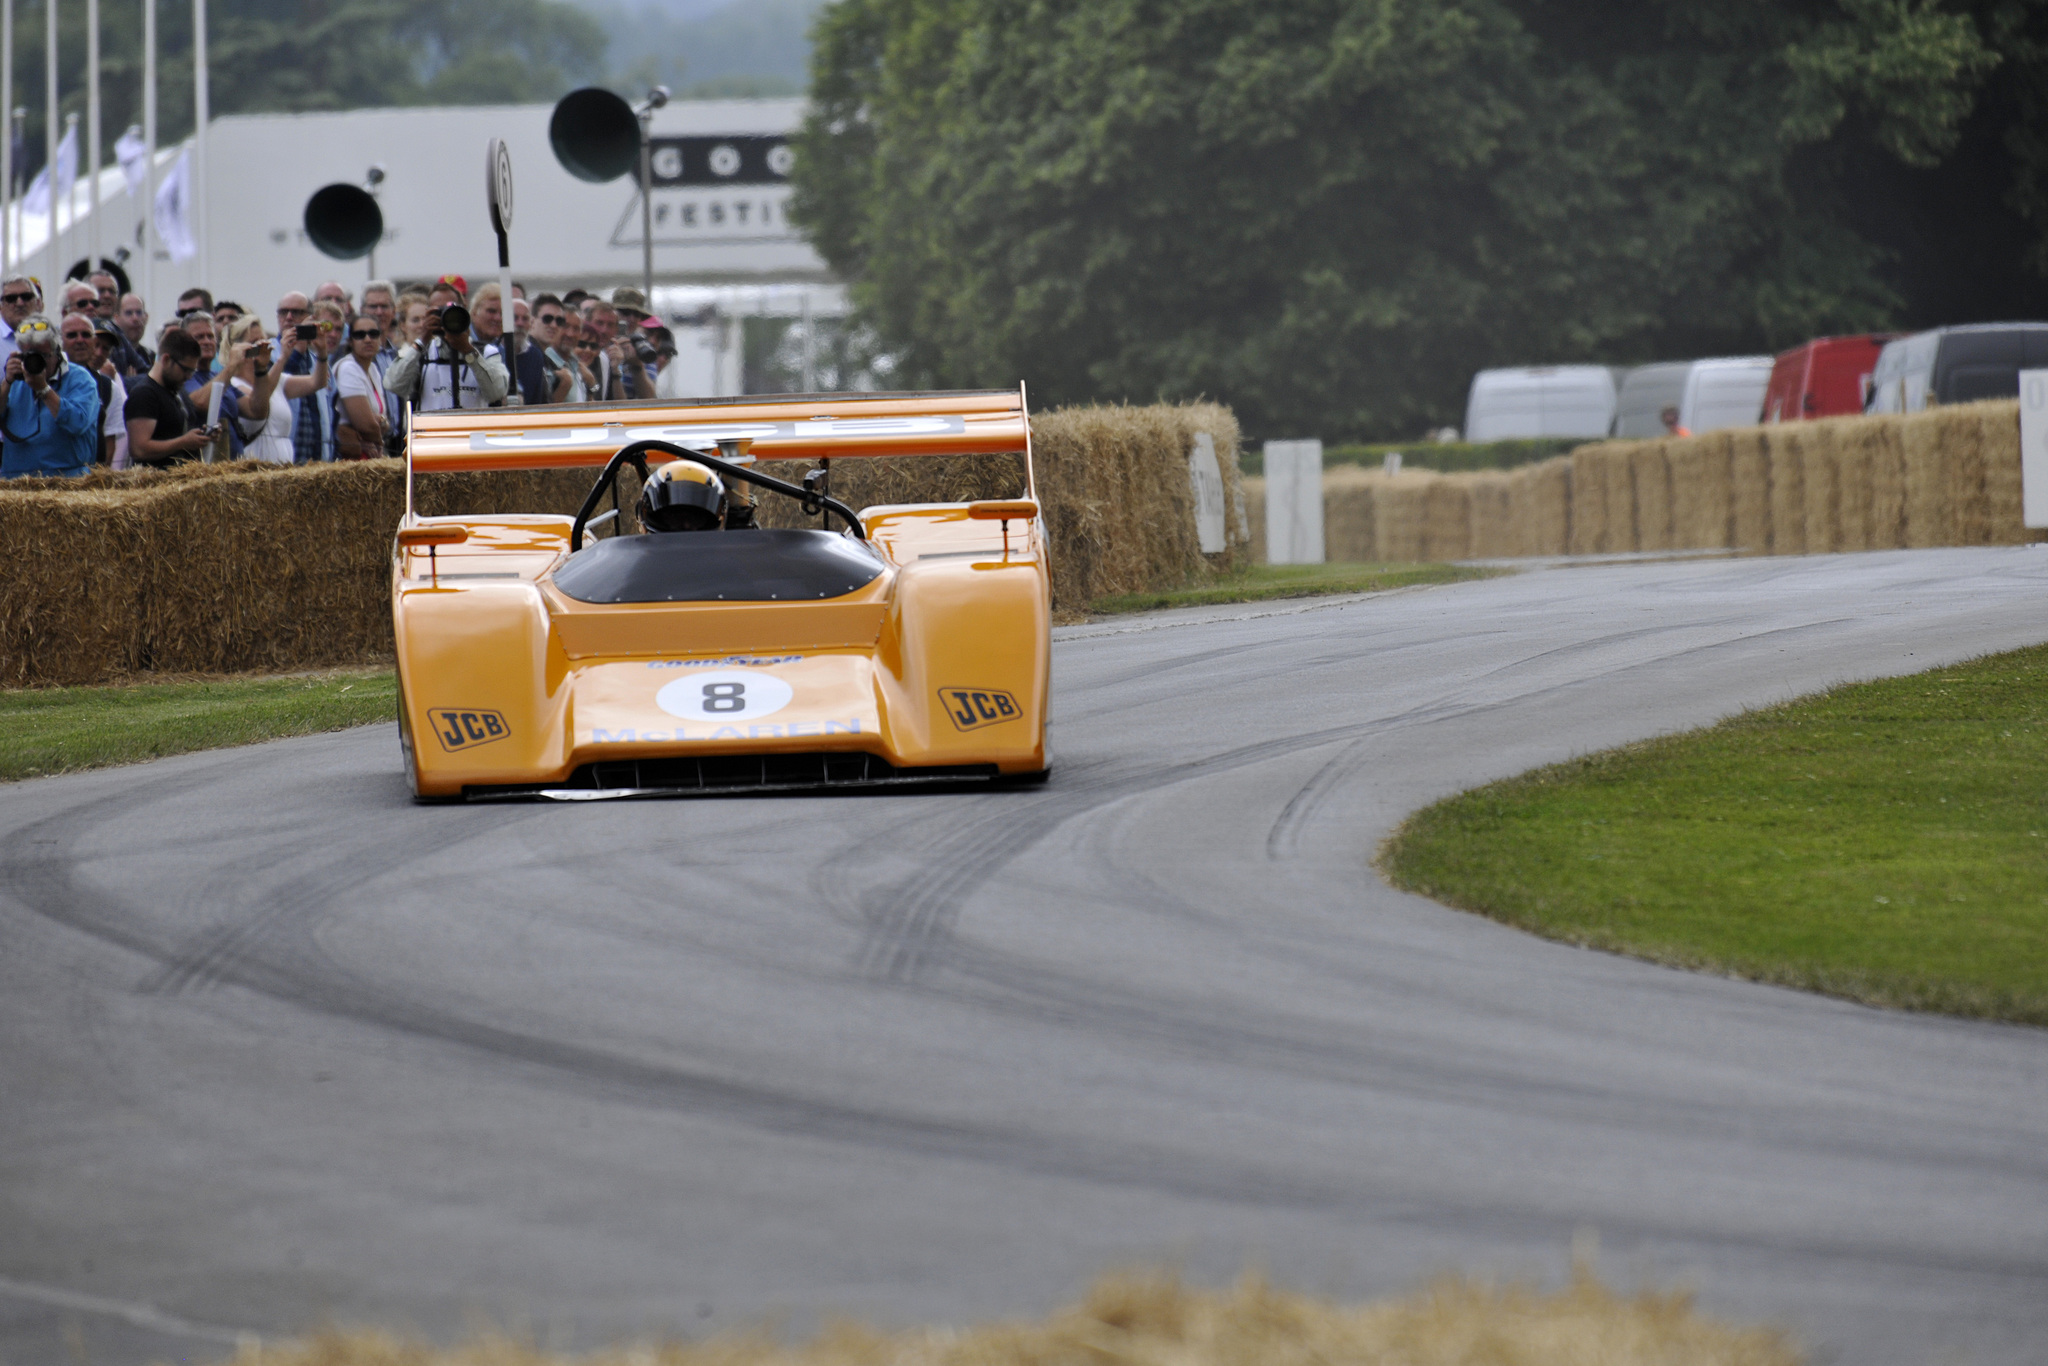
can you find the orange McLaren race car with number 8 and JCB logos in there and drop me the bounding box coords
[391,387,1051,801]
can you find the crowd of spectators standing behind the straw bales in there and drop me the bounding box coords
[0,274,680,477]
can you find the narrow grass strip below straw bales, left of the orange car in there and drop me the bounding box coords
[0,670,397,780]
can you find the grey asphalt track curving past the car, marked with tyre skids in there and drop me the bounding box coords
[0,549,2048,1366]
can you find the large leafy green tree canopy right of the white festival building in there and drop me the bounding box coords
[797,0,2040,438]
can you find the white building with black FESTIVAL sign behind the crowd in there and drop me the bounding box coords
[10,98,846,393]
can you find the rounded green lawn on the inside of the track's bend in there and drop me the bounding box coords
[1380,645,2048,1024]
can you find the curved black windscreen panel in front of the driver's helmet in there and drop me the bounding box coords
[555,530,883,602]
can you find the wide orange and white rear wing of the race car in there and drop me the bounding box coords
[406,385,1038,510]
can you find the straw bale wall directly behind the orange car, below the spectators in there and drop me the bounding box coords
[0,403,1249,686]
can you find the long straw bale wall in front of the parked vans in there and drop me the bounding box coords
[1228,399,2048,561]
